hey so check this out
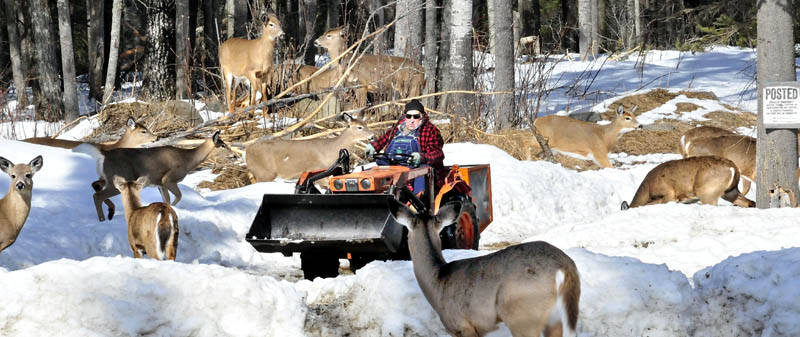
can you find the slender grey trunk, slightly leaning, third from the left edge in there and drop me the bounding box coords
[58,0,80,122]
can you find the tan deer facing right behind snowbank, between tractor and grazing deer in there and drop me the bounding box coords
[533,104,642,168]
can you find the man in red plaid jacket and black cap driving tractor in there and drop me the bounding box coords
[366,99,447,193]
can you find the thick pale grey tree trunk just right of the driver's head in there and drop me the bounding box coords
[445,0,475,120]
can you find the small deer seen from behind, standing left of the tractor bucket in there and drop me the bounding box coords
[114,176,179,261]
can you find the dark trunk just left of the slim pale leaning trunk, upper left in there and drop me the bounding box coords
[86,0,105,101]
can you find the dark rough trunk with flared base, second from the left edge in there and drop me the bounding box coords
[29,0,64,120]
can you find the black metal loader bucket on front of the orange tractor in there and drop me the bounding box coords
[246,194,403,255]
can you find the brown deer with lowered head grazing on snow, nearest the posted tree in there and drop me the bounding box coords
[620,156,755,210]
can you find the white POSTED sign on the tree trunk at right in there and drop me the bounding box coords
[761,82,800,129]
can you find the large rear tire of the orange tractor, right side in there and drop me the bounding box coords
[440,199,480,250]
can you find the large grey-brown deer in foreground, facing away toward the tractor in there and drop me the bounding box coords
[389,199,581,337]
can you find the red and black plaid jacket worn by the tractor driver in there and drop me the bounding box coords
[371,114,447,186]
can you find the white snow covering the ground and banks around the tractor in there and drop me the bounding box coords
[0,48,800,337]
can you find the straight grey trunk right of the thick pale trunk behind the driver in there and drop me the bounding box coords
[491,0,517,129]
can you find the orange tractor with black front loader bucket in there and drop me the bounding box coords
[246,149,492,279]
